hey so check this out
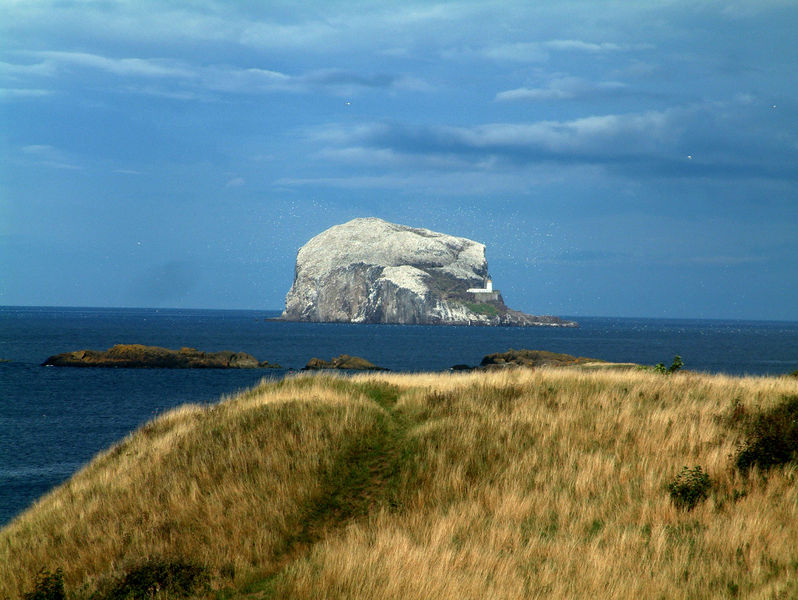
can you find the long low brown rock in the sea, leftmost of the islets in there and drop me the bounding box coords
[42,344,280,369]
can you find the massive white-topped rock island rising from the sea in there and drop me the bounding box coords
[281,218,576,327]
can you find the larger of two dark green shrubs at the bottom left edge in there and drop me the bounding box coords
[93,559,210,600]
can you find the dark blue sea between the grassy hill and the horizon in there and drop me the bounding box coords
[0,306,798,526]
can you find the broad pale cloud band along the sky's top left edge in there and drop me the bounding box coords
[0,0,476,54]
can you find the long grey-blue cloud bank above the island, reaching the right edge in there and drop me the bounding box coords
[310,99,798,181]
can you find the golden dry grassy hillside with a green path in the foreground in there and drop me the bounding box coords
[0,368,798,600]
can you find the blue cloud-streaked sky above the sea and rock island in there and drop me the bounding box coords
[0,0,798,321]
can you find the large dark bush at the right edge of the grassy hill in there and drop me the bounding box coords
[735,396,798,471]
